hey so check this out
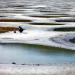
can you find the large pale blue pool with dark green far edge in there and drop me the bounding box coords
[0,44,75,64]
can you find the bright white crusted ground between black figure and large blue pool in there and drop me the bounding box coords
[0,30,75,50]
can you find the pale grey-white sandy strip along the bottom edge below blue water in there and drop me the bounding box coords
[0,64,75,75]
